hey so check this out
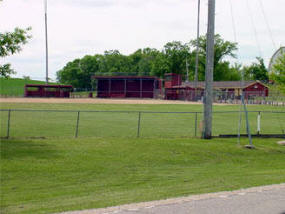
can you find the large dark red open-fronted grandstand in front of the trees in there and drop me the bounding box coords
[93,76,161,98]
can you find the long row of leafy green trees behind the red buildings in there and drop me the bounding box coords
[57,35,269,88]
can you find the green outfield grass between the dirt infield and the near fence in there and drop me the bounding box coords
[0,103,285,138]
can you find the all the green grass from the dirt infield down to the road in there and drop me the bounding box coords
[0,103,285,213]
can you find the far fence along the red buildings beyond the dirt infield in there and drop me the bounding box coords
[0,88,285,106]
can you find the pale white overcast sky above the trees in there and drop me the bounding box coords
[0,0,285,80]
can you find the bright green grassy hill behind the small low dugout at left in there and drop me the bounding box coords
[0,78,57,97]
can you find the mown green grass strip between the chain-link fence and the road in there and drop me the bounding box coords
[1,138,285,214]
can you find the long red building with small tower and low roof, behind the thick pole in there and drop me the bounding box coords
[165,74,269,100]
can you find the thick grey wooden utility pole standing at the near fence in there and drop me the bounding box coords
[203,0,215,139]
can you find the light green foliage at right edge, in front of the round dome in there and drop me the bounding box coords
[272,54,285,93]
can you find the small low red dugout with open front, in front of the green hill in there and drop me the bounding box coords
[25,84,73,97]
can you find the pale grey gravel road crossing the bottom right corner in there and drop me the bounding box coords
[62,183,285,214]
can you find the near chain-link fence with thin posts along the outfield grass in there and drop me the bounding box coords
[0,109,285,138]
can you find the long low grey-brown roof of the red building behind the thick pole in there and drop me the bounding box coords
[172,81,267,89]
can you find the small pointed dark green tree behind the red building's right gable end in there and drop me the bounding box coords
[244,57,269,82]
